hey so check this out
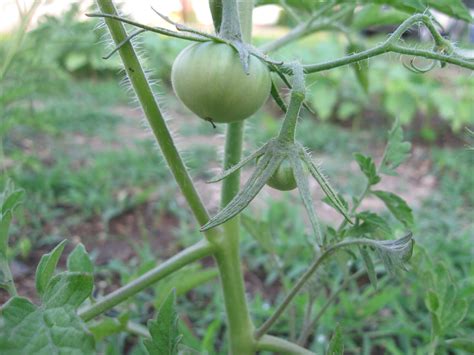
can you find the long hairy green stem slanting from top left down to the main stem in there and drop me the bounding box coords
[97,0,217,241]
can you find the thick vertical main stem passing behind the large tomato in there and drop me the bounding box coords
[214,0,255,355]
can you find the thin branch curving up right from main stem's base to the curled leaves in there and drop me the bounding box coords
[255,238,380,339]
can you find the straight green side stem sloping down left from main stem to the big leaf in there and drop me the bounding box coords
[79,239,215,321]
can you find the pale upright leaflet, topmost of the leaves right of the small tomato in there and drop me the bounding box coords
[380,120,411,175]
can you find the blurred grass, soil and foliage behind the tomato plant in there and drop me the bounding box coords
[0,0,474,354]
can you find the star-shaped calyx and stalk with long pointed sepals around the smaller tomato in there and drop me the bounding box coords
[201,65,352,246]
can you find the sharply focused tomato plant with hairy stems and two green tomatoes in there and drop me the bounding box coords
[0,0,474,355]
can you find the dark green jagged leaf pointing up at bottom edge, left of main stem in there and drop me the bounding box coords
[144,290,181,355]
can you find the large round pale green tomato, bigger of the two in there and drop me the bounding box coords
[171,42,271,123]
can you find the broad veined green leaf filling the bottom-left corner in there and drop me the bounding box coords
[0,280,96,355]
